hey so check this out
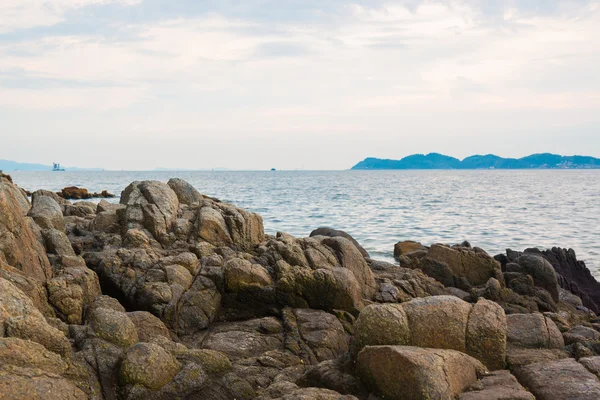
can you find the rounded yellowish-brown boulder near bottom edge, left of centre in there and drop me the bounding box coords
[119,343,181,390]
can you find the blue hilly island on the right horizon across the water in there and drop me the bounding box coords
[351,153,600,170]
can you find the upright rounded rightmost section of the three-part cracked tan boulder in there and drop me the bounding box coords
[466,299,507,370]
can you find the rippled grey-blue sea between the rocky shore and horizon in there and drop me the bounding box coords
[10,170,600,278]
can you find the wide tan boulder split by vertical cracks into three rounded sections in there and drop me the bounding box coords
[352,296,506,369]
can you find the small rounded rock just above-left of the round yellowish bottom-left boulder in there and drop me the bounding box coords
[88,308,139,347]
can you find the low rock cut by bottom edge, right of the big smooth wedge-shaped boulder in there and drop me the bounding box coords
[458,371,535,400]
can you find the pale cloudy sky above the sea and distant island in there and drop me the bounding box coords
[0,0,600,170]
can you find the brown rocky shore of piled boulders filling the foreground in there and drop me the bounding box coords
[0,175,600,400]
